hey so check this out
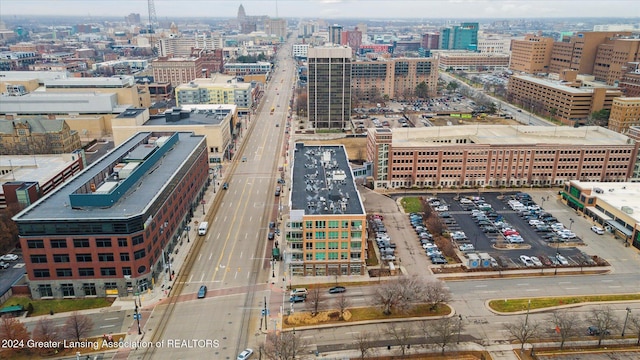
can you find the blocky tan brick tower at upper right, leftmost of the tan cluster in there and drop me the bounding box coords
[509,35,553,74]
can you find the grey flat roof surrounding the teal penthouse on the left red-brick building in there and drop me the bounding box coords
[15,132,205,221]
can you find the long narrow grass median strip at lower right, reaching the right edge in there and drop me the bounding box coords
[489,294,640,313]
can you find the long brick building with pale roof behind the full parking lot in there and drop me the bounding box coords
[367,125,638,189]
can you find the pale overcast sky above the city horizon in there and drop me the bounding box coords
[0,0,640,20]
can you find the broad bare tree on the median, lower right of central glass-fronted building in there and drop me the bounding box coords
[372,276,422,315]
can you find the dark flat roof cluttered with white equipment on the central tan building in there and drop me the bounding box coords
[291,143,364,215]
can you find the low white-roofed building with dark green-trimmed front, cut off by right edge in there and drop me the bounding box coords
[561,180,640,249]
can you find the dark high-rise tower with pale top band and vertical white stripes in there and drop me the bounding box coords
[307,46,351,129]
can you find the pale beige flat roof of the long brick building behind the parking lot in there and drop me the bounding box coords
[382,125,629,147]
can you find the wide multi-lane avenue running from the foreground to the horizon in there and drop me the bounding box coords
[138,34,295,359]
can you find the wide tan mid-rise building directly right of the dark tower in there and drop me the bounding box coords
[351,58,438,102]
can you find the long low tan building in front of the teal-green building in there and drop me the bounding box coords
[435,51,509,71]
